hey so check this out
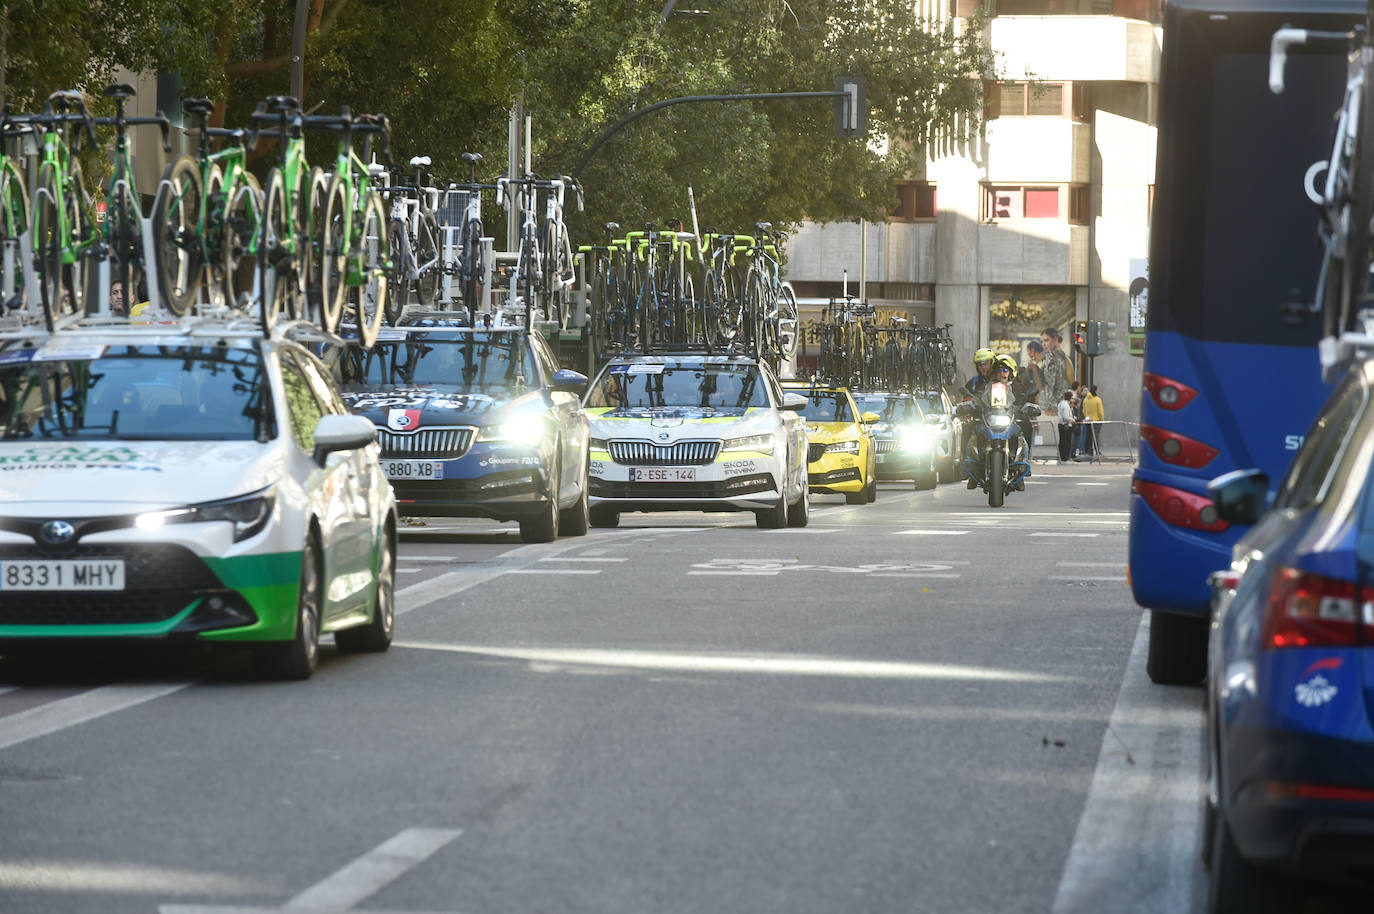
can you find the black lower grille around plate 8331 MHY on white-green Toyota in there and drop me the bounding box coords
[0,544,224,625]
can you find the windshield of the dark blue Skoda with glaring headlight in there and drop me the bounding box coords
[335,330,540,392]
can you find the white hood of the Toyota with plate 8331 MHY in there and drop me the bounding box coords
[0,441,276,514]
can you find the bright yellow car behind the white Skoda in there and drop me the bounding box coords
[783,382,882,504]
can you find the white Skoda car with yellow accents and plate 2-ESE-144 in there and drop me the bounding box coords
[584,355,811,528]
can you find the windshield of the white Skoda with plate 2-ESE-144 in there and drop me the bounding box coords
[587,363,768,410]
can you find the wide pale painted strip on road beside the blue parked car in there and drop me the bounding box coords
[1051,613,1206,914]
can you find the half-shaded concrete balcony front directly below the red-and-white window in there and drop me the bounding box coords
[978,219,1088,286]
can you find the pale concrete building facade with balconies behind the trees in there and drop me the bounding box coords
[787,0,1160,440]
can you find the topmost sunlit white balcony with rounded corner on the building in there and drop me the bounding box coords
[988,15,1160,82]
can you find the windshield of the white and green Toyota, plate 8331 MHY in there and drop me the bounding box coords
[0,345,271,441]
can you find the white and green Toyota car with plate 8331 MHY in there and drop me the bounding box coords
[0,326,396,679]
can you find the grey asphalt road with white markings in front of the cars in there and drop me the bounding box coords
[0,465,1205,914]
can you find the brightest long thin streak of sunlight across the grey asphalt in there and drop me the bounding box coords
[392,640,1079,683]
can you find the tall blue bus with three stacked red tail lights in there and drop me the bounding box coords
[1129,0,1367,684]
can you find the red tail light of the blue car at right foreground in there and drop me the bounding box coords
[1261,568,1374,649]
